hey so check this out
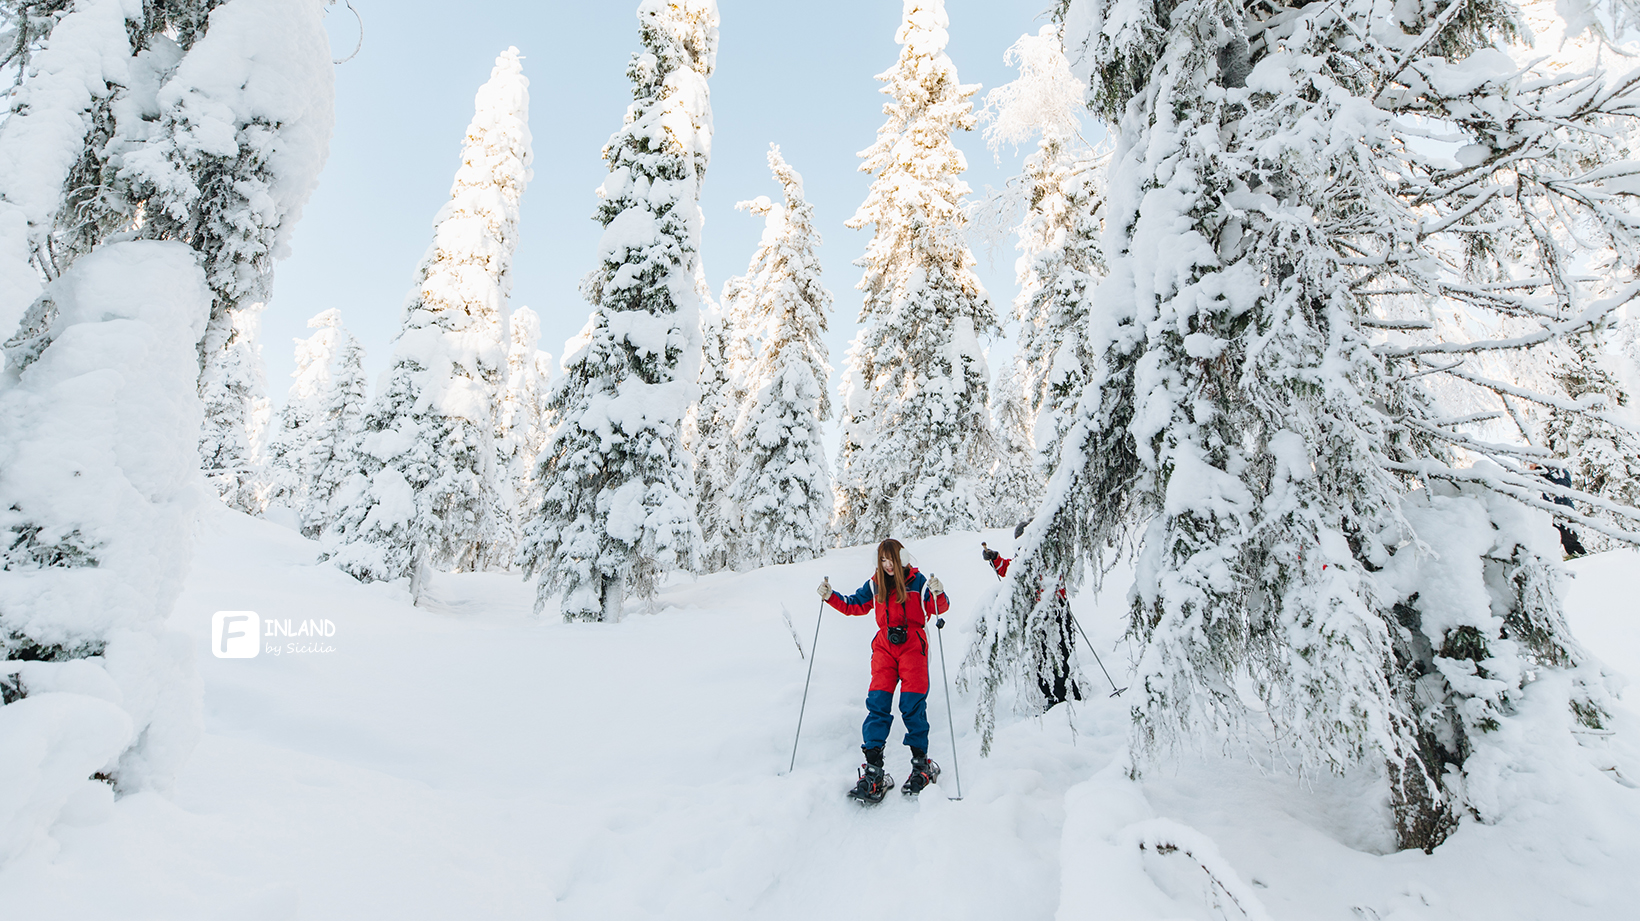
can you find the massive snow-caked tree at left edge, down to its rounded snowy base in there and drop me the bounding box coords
[0,0,333,860]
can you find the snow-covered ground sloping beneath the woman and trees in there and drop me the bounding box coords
[0,510,1640,921]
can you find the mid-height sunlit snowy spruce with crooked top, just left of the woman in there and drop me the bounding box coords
[725,146,833,567]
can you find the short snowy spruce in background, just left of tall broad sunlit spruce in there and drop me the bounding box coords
[267,310,369,538]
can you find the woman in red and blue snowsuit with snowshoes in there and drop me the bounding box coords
[818,539,951,803]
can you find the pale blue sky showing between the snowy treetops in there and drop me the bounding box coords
[275,0,1069,405]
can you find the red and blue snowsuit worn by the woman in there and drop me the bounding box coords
[827,567,951,751]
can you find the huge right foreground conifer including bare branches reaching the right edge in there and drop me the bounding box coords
[971,0,1635,847]
